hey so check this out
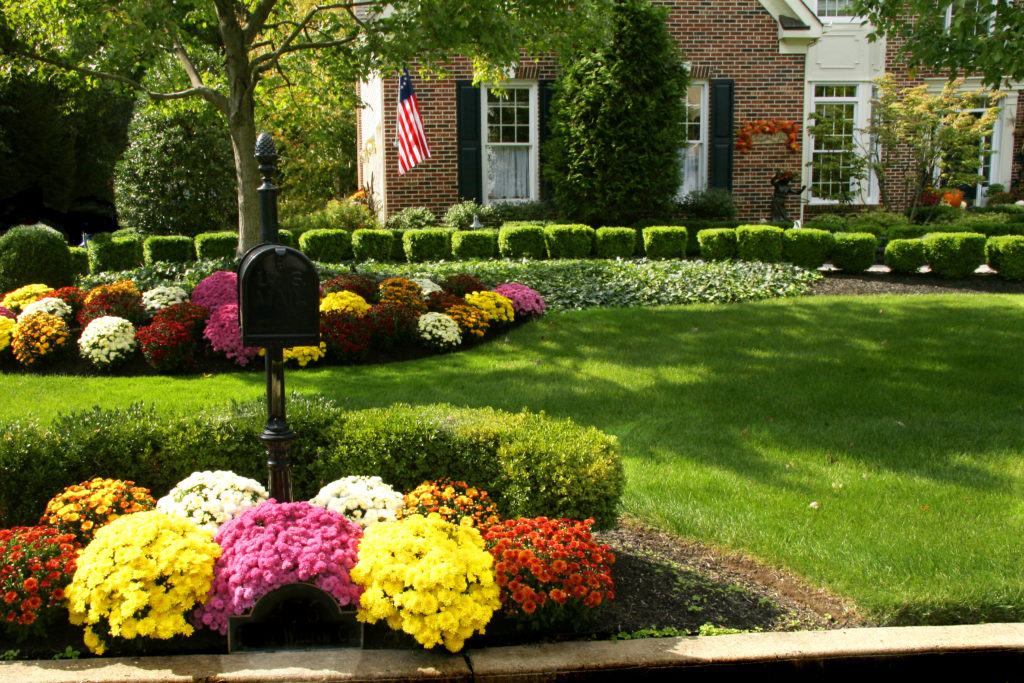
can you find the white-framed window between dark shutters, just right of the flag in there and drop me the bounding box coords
[480,82,539,204]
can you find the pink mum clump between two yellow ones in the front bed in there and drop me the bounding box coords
[193,500,362,634]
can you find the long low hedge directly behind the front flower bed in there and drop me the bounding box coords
[0,396,625,528]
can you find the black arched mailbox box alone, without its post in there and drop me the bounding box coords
[239,244,319,348]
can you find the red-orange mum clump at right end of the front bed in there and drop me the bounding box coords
[483,517,615,626]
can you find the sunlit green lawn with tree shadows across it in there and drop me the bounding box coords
[0,295,1024,623]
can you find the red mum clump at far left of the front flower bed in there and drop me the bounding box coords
[0,526,79,629]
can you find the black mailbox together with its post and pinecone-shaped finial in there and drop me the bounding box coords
[239,133,319,503]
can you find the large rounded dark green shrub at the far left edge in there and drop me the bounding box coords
[0,224,75,292]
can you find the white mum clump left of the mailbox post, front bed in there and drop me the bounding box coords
[157,470,269,533]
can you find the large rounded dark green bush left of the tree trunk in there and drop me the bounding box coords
[114,100,239,237]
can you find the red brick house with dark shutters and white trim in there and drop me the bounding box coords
[357,0,1024,220]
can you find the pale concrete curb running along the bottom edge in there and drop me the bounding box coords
[0,624,1024,683]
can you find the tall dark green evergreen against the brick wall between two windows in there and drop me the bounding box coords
[545,0,688,225]
